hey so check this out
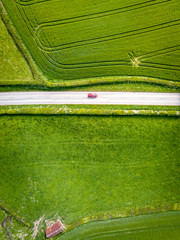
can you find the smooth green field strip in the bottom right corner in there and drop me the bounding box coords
[58,212,180,240]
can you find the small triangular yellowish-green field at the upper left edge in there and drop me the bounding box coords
[0,15,33,84]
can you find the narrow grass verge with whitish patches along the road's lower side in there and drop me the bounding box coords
[0,105,180,117]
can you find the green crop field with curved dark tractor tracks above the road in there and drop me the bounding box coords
[2,0,180,82]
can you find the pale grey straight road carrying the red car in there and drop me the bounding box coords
[0,92,180,106]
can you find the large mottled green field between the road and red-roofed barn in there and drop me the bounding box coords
[0,115,180,240]
